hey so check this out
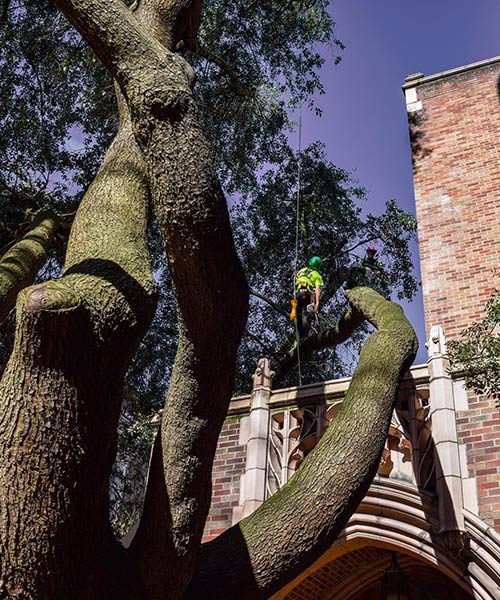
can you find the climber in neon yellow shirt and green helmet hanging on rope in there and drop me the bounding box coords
[291,256,323,339]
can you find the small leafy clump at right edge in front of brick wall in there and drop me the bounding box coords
[447,290,500,403]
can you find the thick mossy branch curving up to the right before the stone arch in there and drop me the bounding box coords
[185,288,417,600]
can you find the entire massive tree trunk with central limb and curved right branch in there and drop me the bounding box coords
[0,0,422,600]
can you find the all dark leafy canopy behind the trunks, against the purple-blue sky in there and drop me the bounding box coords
[0,0,416,532]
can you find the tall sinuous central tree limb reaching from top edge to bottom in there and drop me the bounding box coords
[48,0,248,599]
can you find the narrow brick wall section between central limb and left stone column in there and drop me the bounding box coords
[203,417,246,542]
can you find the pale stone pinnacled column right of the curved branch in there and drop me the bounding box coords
[427,326,465,551]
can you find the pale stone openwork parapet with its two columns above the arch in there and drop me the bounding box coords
[230,327,474,548]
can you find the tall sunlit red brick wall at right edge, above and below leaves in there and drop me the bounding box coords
[404,58,500,530]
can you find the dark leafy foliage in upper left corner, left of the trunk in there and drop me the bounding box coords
[0,0,117,254]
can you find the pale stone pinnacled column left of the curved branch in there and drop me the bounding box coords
[240,358,274,517]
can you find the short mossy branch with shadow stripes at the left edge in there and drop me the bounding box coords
[0,213,58,323]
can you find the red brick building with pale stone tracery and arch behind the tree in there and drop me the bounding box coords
[197,57,500,600]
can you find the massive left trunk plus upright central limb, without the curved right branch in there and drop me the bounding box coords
[0,0,248,599]
